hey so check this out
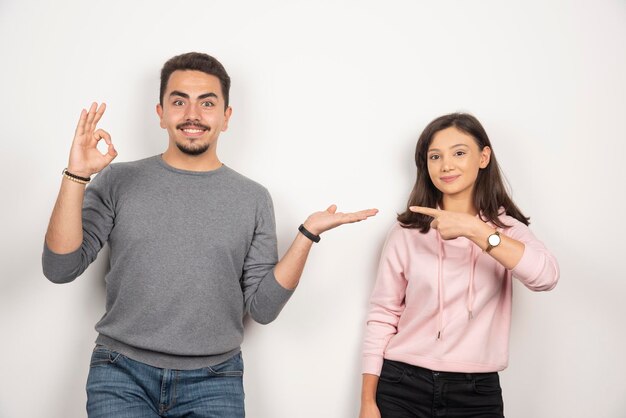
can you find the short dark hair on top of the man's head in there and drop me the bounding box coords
[159,52,230,109]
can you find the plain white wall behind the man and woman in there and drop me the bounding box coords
[0,0,626,418]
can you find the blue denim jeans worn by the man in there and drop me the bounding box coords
[87,345,245,418]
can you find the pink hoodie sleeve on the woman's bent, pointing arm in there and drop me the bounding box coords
[504,221,559,292]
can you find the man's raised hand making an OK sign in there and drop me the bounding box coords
[67,103,117,177]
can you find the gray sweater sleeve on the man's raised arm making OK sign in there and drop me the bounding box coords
[42,166,115,283]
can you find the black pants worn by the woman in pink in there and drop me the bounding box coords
[376,360,504,418]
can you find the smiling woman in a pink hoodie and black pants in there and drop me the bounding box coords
[360,113,559,418]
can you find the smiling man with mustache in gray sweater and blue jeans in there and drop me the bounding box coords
[43,53,376,418]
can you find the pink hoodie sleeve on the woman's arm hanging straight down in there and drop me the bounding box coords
[362,224,408,376]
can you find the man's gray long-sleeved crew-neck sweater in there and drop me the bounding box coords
[42,156,292,370]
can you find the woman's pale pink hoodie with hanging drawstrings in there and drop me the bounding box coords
[363,215,559,375]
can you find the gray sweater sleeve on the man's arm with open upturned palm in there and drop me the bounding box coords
[241,190,294,324]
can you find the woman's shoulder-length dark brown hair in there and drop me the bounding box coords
[398,113,529,233]
